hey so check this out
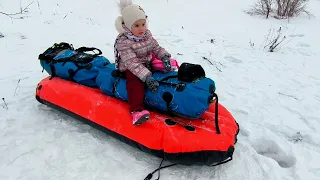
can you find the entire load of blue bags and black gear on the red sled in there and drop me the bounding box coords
[39,43,218,119]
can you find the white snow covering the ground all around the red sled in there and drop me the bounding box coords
[0,0,320,180]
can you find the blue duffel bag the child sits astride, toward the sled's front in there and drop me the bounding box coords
[96,64,216,118]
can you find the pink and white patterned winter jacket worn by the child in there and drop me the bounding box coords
[114,30,171,82]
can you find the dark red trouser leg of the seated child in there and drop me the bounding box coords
[126,70,144,112]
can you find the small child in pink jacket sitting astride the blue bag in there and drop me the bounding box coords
[114,0,172,125]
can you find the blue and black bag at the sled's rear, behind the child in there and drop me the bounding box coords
[39,42,110,87]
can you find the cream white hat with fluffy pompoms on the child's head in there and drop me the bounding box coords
[115,0,147,33]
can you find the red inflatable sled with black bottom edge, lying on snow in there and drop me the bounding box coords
[36,77,239,165]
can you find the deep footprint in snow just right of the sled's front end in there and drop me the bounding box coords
[253,139,297,168]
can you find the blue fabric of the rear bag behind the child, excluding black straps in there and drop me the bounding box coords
[40,49,110,87]
